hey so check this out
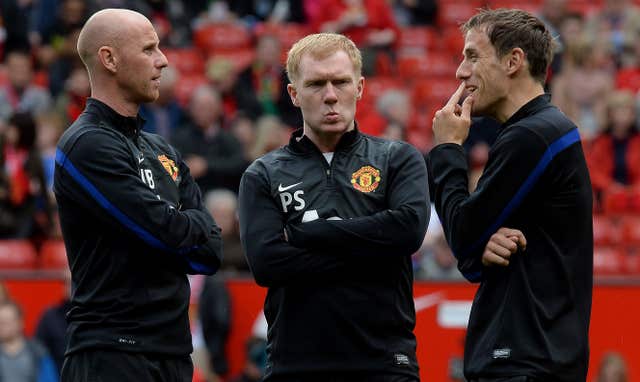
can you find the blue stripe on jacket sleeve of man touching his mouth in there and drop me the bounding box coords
[456,128,580,280]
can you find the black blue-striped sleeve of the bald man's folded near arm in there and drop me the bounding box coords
[56,130,215,254]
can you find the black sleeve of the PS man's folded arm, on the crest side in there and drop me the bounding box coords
[287,144,431,256]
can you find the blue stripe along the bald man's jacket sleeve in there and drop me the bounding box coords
[56,149,196,254]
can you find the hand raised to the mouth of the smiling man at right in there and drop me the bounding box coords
[432,82,473,145]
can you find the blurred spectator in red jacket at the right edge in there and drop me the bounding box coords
[587,91,640,209]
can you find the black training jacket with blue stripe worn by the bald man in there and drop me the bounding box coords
[54,99,222,355]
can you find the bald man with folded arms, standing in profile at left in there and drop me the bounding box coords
[54,9,222,382]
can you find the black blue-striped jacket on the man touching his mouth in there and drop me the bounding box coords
[428,95,593,382]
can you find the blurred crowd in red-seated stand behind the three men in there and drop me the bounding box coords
[0,0,640,279]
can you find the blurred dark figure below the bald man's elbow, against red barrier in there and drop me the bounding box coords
[198,276,232,382]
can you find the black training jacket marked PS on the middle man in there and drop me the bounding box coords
[239,129,430,380]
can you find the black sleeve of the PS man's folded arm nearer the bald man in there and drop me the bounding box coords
[238,171,346,287]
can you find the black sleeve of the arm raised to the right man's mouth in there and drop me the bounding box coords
[428,126,547,281]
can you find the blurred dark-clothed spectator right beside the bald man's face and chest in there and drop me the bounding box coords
[172,85,247,193]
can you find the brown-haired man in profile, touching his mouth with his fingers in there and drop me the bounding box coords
[428,9,593,382]
